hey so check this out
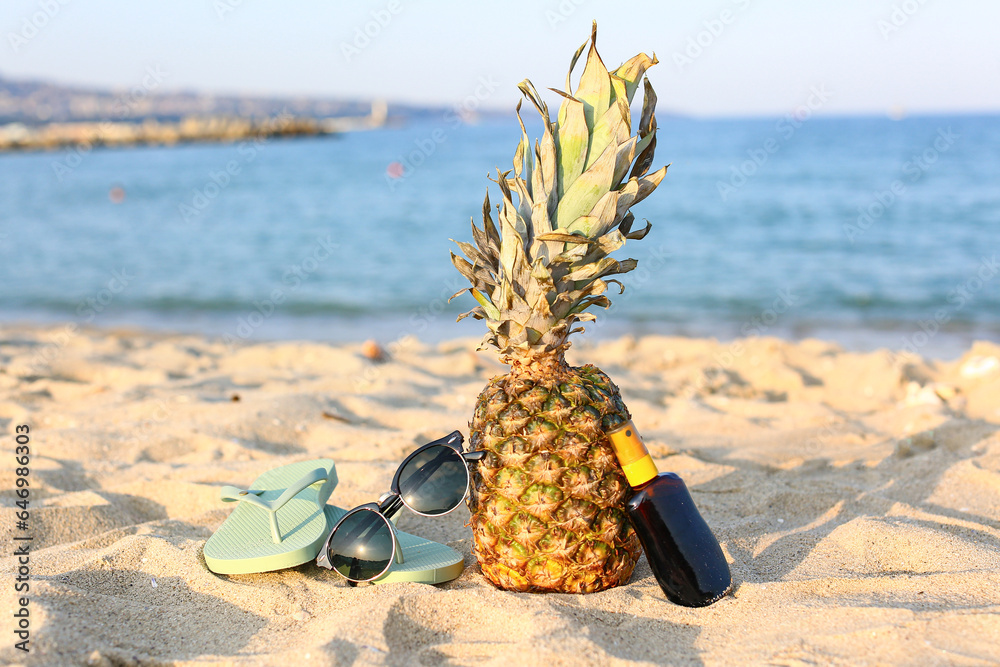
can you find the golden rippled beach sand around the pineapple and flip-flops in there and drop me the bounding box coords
[0,326,1000,666]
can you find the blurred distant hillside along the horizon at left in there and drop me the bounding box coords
[0,73,488,125]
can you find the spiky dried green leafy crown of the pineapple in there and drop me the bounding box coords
[451,21,667,359]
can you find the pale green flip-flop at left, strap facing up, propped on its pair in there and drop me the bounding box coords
[204,459,337,574]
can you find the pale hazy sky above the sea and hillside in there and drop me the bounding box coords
[0,0,1000,116]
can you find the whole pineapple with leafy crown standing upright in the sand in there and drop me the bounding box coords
[452,22,667,593]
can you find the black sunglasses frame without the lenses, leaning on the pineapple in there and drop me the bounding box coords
[316,431,486,586]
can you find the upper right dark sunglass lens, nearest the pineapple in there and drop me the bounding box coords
[399,445,469,515]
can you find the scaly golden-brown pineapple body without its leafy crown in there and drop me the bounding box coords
[468,355,641,593]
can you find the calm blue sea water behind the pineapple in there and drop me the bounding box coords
[0,116,1000,356]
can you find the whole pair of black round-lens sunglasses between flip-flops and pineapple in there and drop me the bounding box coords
[316,431,486,585]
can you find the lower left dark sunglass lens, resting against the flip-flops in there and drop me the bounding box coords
[327,510,393,581]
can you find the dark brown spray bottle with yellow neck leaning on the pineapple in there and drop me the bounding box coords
[607,421,732,607]
